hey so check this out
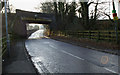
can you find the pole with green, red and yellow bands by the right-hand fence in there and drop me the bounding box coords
[112,0,118,44]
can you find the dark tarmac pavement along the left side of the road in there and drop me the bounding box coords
[2,40,38,75]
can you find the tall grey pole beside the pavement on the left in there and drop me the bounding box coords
[4,0,10,56]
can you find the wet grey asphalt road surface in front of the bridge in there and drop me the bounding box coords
[25,39,119,73]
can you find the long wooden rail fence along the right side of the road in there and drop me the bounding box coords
[52,30,120,42]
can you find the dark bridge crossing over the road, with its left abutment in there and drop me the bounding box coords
[10,9,55,38]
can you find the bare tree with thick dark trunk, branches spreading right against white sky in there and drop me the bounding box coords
[78,0,110,29]
